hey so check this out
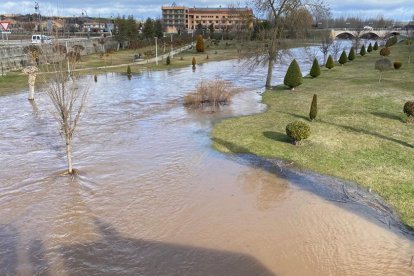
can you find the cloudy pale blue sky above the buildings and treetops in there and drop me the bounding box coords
[0,0,414,21]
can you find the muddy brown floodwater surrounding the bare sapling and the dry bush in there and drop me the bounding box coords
[0,50,414,275]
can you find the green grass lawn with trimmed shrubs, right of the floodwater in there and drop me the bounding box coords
[212,45,414,227]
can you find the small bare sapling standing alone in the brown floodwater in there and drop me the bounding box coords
[43,44,89,174]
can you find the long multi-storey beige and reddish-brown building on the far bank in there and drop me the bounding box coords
[162,4,253,33]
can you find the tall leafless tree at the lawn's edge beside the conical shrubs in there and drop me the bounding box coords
[247,0,322,88]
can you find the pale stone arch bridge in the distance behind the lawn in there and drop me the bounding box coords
[331,28,403,39]
